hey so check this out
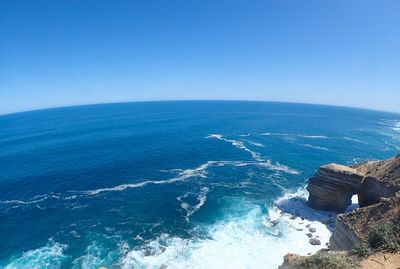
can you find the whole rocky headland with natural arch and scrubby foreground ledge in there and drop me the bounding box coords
[280,154,400,269]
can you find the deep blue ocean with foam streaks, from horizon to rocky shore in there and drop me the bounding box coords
[0,101,400,268]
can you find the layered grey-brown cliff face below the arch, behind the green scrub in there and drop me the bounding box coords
[329,193,400,250]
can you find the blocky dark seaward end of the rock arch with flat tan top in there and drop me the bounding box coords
[307,164,364,212]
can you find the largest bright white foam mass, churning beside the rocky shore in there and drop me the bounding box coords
[120,188,330,269]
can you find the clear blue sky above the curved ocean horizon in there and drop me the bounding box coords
[0,0,400,114]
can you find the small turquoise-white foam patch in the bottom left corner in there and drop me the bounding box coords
[4,239,68,269]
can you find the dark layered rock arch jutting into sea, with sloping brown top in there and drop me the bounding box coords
[307,154,400,213]
